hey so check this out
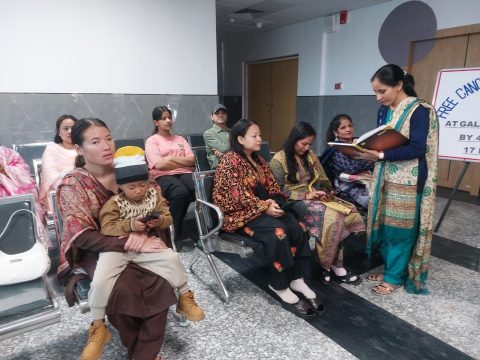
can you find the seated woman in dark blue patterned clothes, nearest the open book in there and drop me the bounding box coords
[320,114,375,212]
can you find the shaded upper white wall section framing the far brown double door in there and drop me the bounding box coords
[224,18,325,96]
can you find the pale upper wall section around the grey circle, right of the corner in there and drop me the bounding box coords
[320,0,480,95]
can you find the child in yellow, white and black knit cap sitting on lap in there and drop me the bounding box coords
[88,146,205,330]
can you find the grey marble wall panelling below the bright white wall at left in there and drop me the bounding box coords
[0,93,218,147]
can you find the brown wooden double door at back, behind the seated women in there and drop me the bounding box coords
[247,59,298,151]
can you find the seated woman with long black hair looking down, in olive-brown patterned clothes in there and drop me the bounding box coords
[270,122,365,285]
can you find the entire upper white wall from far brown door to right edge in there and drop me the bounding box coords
[225,0,480,96]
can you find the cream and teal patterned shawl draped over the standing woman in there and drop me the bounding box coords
[367,97,438,294]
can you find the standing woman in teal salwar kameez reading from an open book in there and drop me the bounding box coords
[361,64,438,295]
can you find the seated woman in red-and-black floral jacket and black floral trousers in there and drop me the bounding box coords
[213,119,324,316]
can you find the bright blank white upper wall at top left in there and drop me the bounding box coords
[0,0,217,95]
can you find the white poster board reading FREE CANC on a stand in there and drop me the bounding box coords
[433,68,480,162]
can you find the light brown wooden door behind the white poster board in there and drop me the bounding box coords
[408,25,480,195]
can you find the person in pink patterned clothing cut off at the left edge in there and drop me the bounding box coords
[0,146,50,246]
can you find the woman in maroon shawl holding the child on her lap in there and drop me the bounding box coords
[57,118,177,360]
